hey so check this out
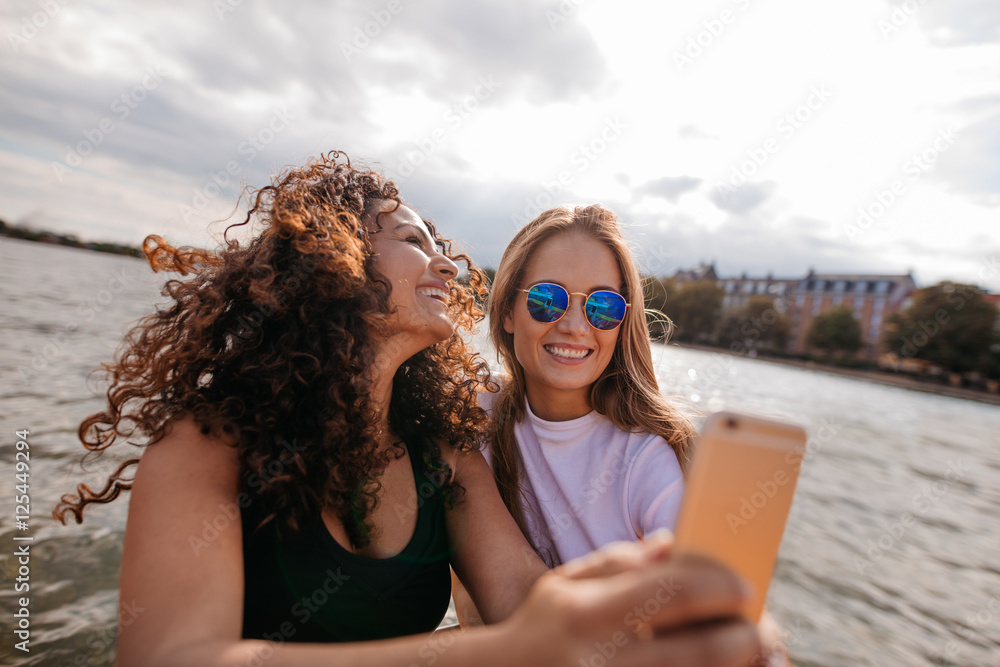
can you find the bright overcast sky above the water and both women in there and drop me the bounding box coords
[0,0,1000,291]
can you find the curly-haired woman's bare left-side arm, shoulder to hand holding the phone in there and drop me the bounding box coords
[118,420,757,667]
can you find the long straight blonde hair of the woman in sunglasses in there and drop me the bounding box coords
[487,204,695,549]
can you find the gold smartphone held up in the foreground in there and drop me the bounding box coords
[674,412,806,622]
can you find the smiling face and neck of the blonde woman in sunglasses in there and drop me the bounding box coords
[504,231,622,421]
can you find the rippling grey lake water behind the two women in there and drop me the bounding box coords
[0,239,1000,667]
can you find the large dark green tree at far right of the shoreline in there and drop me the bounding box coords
[882,282,997,373]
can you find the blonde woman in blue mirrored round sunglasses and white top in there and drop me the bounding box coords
[455,205,780,662]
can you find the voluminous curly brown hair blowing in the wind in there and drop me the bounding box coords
[53,151,488,547]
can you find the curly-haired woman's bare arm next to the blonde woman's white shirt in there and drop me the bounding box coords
[443,450,548,623]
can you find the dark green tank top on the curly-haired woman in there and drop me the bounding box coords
[243,442,451,642]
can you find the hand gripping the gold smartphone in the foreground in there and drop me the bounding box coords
[514,544,762,667]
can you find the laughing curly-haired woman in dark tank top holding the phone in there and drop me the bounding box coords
[56,153,758,667]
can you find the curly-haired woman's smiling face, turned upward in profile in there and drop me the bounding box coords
[366,200,458,354]
